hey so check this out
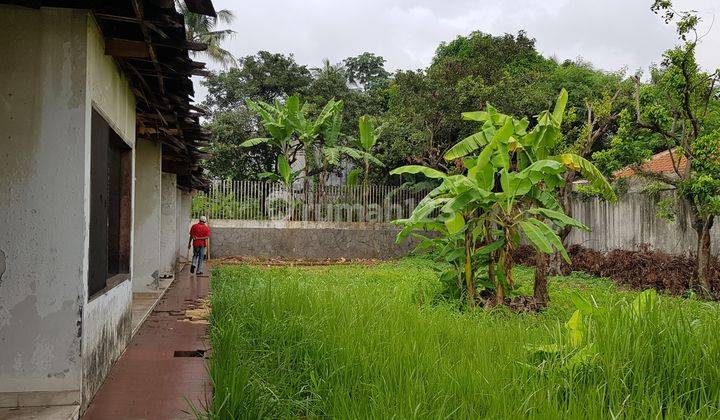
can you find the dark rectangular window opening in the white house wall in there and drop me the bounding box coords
[88,109,132,296]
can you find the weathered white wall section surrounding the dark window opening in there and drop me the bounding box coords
[82,15,135,406]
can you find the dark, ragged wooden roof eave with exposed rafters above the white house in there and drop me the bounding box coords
[0,0,216,189]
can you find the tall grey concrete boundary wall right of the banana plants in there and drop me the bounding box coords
[569,192,720,255]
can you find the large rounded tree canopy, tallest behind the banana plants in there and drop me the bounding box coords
[378,32,621,184]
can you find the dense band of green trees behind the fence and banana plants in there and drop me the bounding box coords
[200,32,620,183]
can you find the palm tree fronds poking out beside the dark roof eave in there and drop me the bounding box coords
[176,0,237,68]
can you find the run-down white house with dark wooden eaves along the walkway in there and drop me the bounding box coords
[0,0,215,409]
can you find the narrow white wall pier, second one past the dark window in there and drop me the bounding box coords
[160,172,178,276]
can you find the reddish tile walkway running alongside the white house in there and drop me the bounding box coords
[83,267,211,420]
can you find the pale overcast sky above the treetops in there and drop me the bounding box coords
[196,0,720,100]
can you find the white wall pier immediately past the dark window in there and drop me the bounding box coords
[133,140,162,292]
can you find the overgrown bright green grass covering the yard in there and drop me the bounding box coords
[210,259,720,419]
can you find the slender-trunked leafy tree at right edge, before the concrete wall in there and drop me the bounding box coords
[597,0,720,291]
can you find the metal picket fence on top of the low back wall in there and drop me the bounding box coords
[193,180,428,223]
